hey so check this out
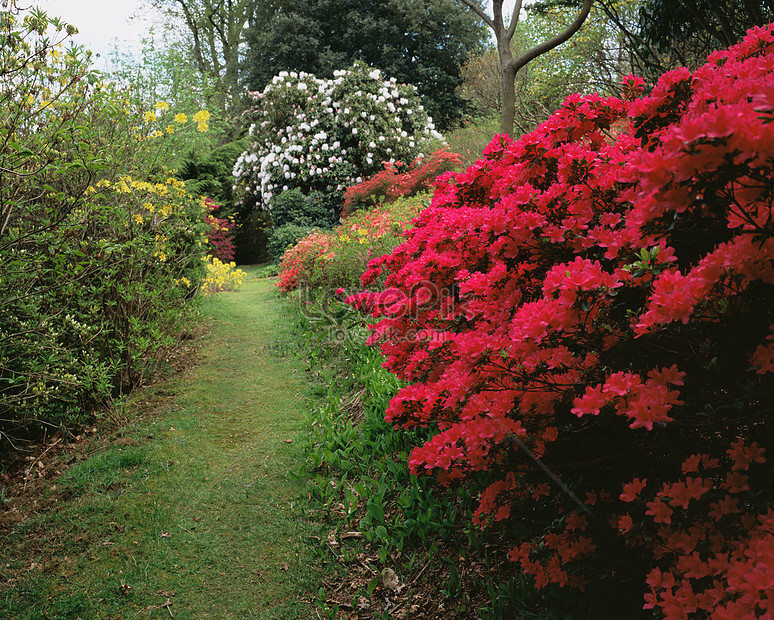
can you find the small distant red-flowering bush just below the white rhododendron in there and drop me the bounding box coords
[342,149,462,217]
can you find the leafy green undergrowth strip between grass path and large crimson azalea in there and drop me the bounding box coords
[293,300,540,620]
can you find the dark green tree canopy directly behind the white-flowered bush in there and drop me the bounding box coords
[244,0,487,127]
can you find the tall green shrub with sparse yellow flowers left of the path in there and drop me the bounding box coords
[0,10,209,448]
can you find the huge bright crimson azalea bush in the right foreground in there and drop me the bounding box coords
[349,27,774,618]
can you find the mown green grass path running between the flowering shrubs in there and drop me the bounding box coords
[0,273,322,620]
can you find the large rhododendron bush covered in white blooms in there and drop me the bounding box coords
[233,63,442,209]
